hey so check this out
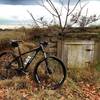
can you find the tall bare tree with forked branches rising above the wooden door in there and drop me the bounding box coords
[40,0,82,33]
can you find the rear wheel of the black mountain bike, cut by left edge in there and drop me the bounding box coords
[0,51,19,79]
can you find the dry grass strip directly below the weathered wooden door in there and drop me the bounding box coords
[68,67,100,83]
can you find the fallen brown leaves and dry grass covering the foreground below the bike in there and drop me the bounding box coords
[0,77,100,100]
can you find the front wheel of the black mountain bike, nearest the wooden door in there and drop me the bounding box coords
[33,57,66,89]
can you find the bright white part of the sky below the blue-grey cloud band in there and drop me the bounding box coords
[0,1,100,28]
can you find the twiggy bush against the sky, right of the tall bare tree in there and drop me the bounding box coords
[70,5,100,28]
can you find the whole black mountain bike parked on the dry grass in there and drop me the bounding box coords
[0,40,66,89]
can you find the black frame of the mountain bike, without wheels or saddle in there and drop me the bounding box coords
[9,44,47,71]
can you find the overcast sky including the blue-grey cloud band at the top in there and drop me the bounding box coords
[0,0,100,28]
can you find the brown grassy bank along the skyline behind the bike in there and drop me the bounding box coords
[0,26,100,40]
